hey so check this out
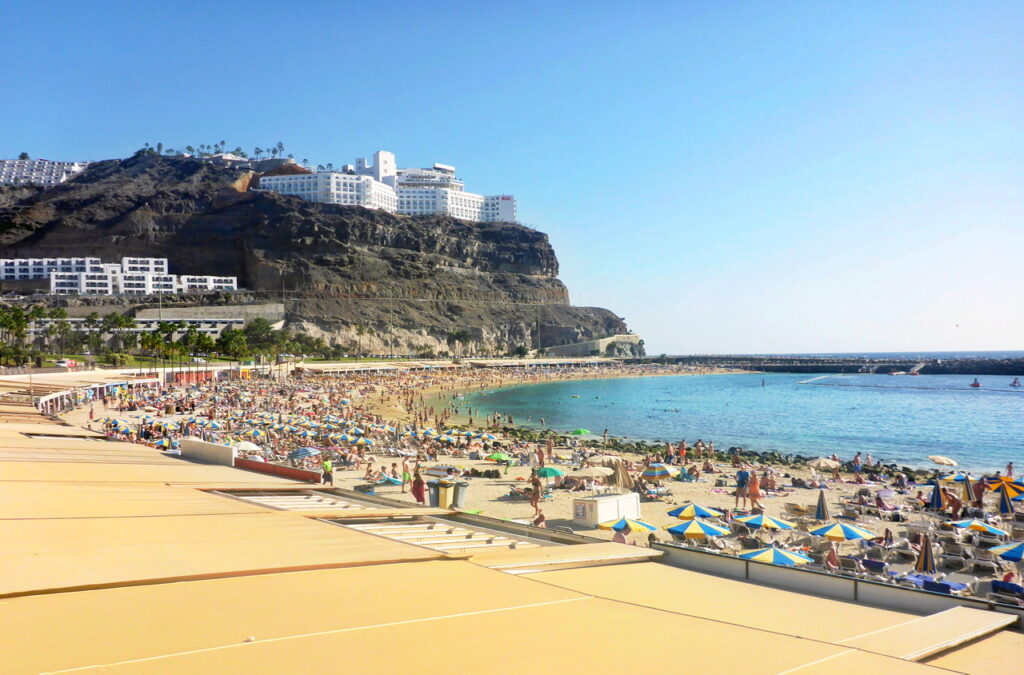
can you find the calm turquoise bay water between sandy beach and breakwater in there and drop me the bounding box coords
[467,374,1024,471]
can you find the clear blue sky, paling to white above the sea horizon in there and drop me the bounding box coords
[0,0,1024,353]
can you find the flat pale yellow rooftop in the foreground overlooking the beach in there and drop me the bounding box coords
[0,366,1024,673]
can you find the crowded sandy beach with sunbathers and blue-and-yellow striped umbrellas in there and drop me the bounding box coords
[65,365,1024,605]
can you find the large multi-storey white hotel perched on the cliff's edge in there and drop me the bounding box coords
[259,151,518,222]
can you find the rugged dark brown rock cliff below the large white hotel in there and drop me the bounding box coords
[0,156,638,352]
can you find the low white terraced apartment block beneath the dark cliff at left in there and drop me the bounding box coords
[0,258,239,295]
